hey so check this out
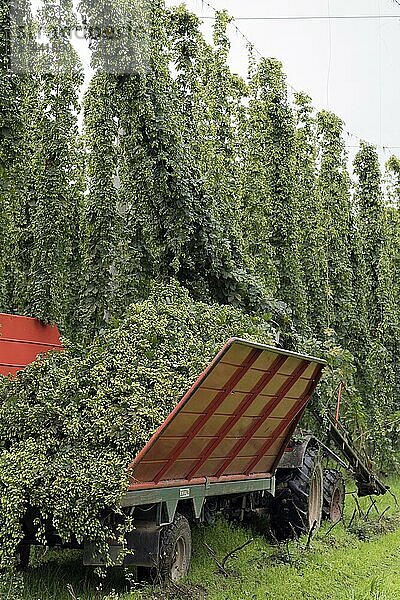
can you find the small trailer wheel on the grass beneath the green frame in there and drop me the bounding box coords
[158,513,192,581]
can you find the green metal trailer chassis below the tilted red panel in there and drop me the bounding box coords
[83,476,275,568]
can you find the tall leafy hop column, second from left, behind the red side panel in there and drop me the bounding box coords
[26,15,83,328]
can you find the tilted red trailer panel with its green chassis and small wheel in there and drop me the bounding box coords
[85,339,325,579]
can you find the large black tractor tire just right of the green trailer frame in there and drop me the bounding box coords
[270,445,323,541]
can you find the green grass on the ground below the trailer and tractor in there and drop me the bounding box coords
[7,481,400,600]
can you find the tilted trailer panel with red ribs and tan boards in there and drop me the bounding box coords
[129,338,325,491]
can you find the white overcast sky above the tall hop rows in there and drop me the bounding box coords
[167,0,400,160]
